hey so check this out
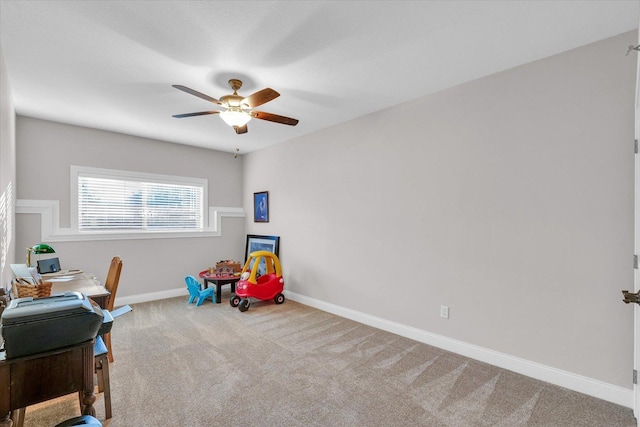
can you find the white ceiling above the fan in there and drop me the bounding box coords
[0,0,639,153]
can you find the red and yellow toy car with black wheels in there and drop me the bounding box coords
[229,251,284,311]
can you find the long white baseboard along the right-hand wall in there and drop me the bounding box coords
[284,291,633,408]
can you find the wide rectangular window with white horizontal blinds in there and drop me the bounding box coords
[71,166,207,232]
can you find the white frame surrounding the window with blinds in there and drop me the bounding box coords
[70,165,209,238]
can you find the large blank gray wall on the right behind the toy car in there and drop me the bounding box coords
[243,32,636,389]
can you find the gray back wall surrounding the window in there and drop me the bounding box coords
[16,116,245,304]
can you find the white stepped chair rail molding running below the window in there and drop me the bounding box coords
[16,199,246,242]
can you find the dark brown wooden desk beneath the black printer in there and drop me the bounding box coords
[0,340,96,427]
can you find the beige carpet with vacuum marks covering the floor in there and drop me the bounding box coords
[20,293,636,427]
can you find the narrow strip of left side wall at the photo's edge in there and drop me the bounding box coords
[0,46,16,288]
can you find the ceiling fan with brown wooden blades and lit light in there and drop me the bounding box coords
[172,79,298,134]
